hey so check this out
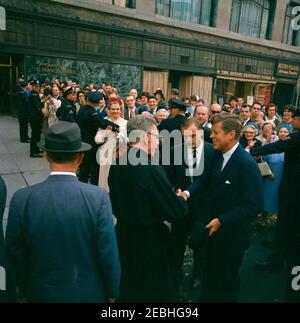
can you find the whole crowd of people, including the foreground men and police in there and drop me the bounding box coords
[3,79,300,302]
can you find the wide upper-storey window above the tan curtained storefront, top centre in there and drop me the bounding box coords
[156,0,218,27]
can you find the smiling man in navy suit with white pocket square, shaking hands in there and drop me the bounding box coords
[178,113,263,302]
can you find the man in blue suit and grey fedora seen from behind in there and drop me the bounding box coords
[6,121,120,303]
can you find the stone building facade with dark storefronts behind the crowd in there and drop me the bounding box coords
[0,0,300,114]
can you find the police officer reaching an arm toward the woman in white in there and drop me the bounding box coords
[77,92,119,185]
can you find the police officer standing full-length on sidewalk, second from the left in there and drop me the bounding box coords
[28,80,49,158]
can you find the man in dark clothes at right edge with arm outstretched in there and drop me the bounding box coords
[251,109,300,302]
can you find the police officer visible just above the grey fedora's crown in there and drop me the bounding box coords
[56,87,77,122]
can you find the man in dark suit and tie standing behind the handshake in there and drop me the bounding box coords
[163,118,214,296]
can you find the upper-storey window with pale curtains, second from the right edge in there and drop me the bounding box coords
[230,0,275,39]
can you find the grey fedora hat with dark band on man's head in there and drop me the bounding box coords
[39,121,92,153]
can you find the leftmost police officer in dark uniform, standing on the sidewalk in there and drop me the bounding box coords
[16,81,30,143]
